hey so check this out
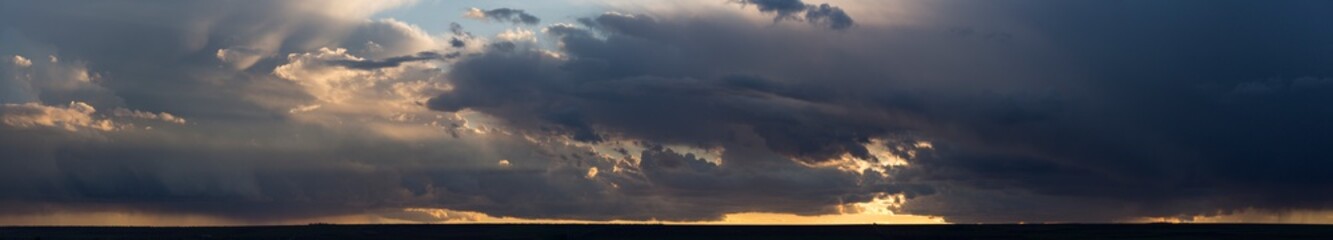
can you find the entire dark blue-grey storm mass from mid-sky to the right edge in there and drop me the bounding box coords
[429,1,1333,221]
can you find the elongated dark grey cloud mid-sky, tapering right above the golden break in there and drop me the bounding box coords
[428,13,933,163]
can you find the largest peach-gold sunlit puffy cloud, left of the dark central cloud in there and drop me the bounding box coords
[273,48,467,140]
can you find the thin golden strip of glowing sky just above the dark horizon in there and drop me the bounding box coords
[18,206,1333,227]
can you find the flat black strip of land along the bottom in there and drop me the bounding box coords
[0,224,1333,240]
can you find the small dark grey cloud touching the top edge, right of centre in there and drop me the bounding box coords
[738,0,854,29]
